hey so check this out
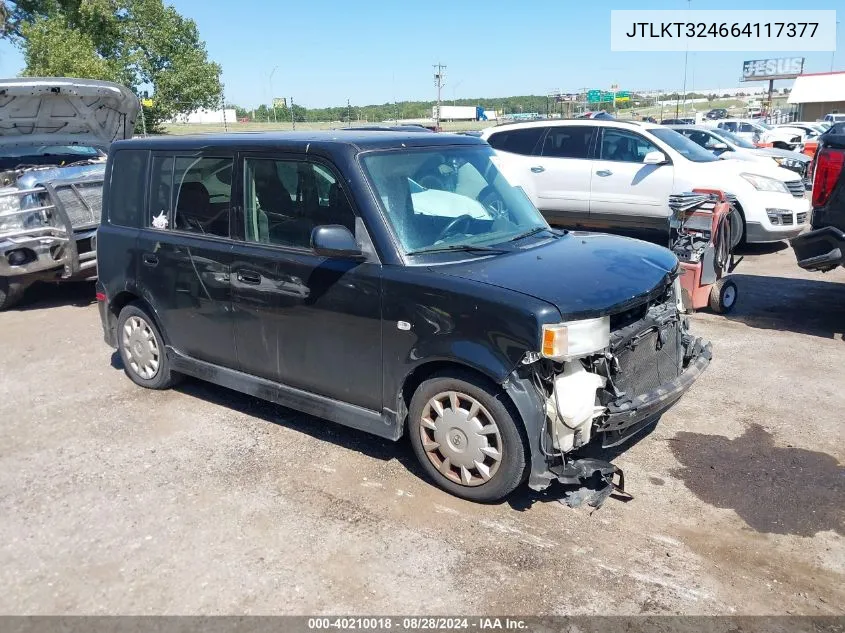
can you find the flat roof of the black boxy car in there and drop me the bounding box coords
[112,130,485,151]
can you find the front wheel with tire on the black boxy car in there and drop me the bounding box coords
[408,374,527,502]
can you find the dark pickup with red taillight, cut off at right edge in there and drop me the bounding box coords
[792,123,845,272]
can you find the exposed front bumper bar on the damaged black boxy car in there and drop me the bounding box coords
[596,339,713,448]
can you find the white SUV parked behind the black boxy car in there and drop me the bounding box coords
[481,120,810,242]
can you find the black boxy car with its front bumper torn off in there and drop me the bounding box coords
[97,130,711,501]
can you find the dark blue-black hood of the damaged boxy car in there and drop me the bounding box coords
[433,232,678,320]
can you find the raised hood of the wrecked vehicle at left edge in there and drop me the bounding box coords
[0,77,141,150]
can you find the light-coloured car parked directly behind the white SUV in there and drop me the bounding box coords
[670,125,811,185]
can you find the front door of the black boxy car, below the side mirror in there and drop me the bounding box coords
[231,154,382,411]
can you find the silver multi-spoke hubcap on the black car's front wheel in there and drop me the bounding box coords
[420,391,502,486]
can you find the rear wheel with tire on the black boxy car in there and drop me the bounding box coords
[117,303,176,389]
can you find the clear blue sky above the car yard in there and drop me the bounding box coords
[0,0,845,107]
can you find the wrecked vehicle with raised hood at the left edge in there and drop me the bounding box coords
[0,78,140,310]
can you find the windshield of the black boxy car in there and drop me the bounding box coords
[362,146,548,253]
